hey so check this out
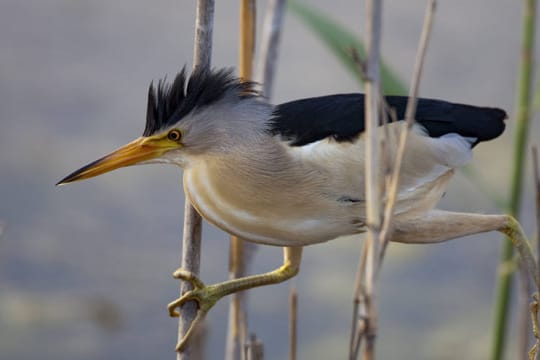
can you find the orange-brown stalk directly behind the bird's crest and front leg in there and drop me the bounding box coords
[225,0,255,360]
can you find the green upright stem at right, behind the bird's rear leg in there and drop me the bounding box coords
[490,0,537,360]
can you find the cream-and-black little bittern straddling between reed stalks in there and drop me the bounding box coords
[57,67,526,350]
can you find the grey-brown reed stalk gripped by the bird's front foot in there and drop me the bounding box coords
[176,0,214,360]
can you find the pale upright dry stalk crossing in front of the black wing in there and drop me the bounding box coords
[363,0,382,360]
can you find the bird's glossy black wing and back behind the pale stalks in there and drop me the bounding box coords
[271,94,506,146]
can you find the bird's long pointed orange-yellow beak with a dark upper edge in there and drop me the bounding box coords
[56,137,171,185]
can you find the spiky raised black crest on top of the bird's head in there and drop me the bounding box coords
[143,67,259,136]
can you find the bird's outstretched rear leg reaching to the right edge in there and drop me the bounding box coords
[390,210,540,287]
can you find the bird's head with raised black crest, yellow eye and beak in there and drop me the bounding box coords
[57,68,268,185]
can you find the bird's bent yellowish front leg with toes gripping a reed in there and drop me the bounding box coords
[168,247,302,351]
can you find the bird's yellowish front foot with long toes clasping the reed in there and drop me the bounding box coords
[167,269,223,351]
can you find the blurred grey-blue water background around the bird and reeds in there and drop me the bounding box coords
[0,0,539,360]
